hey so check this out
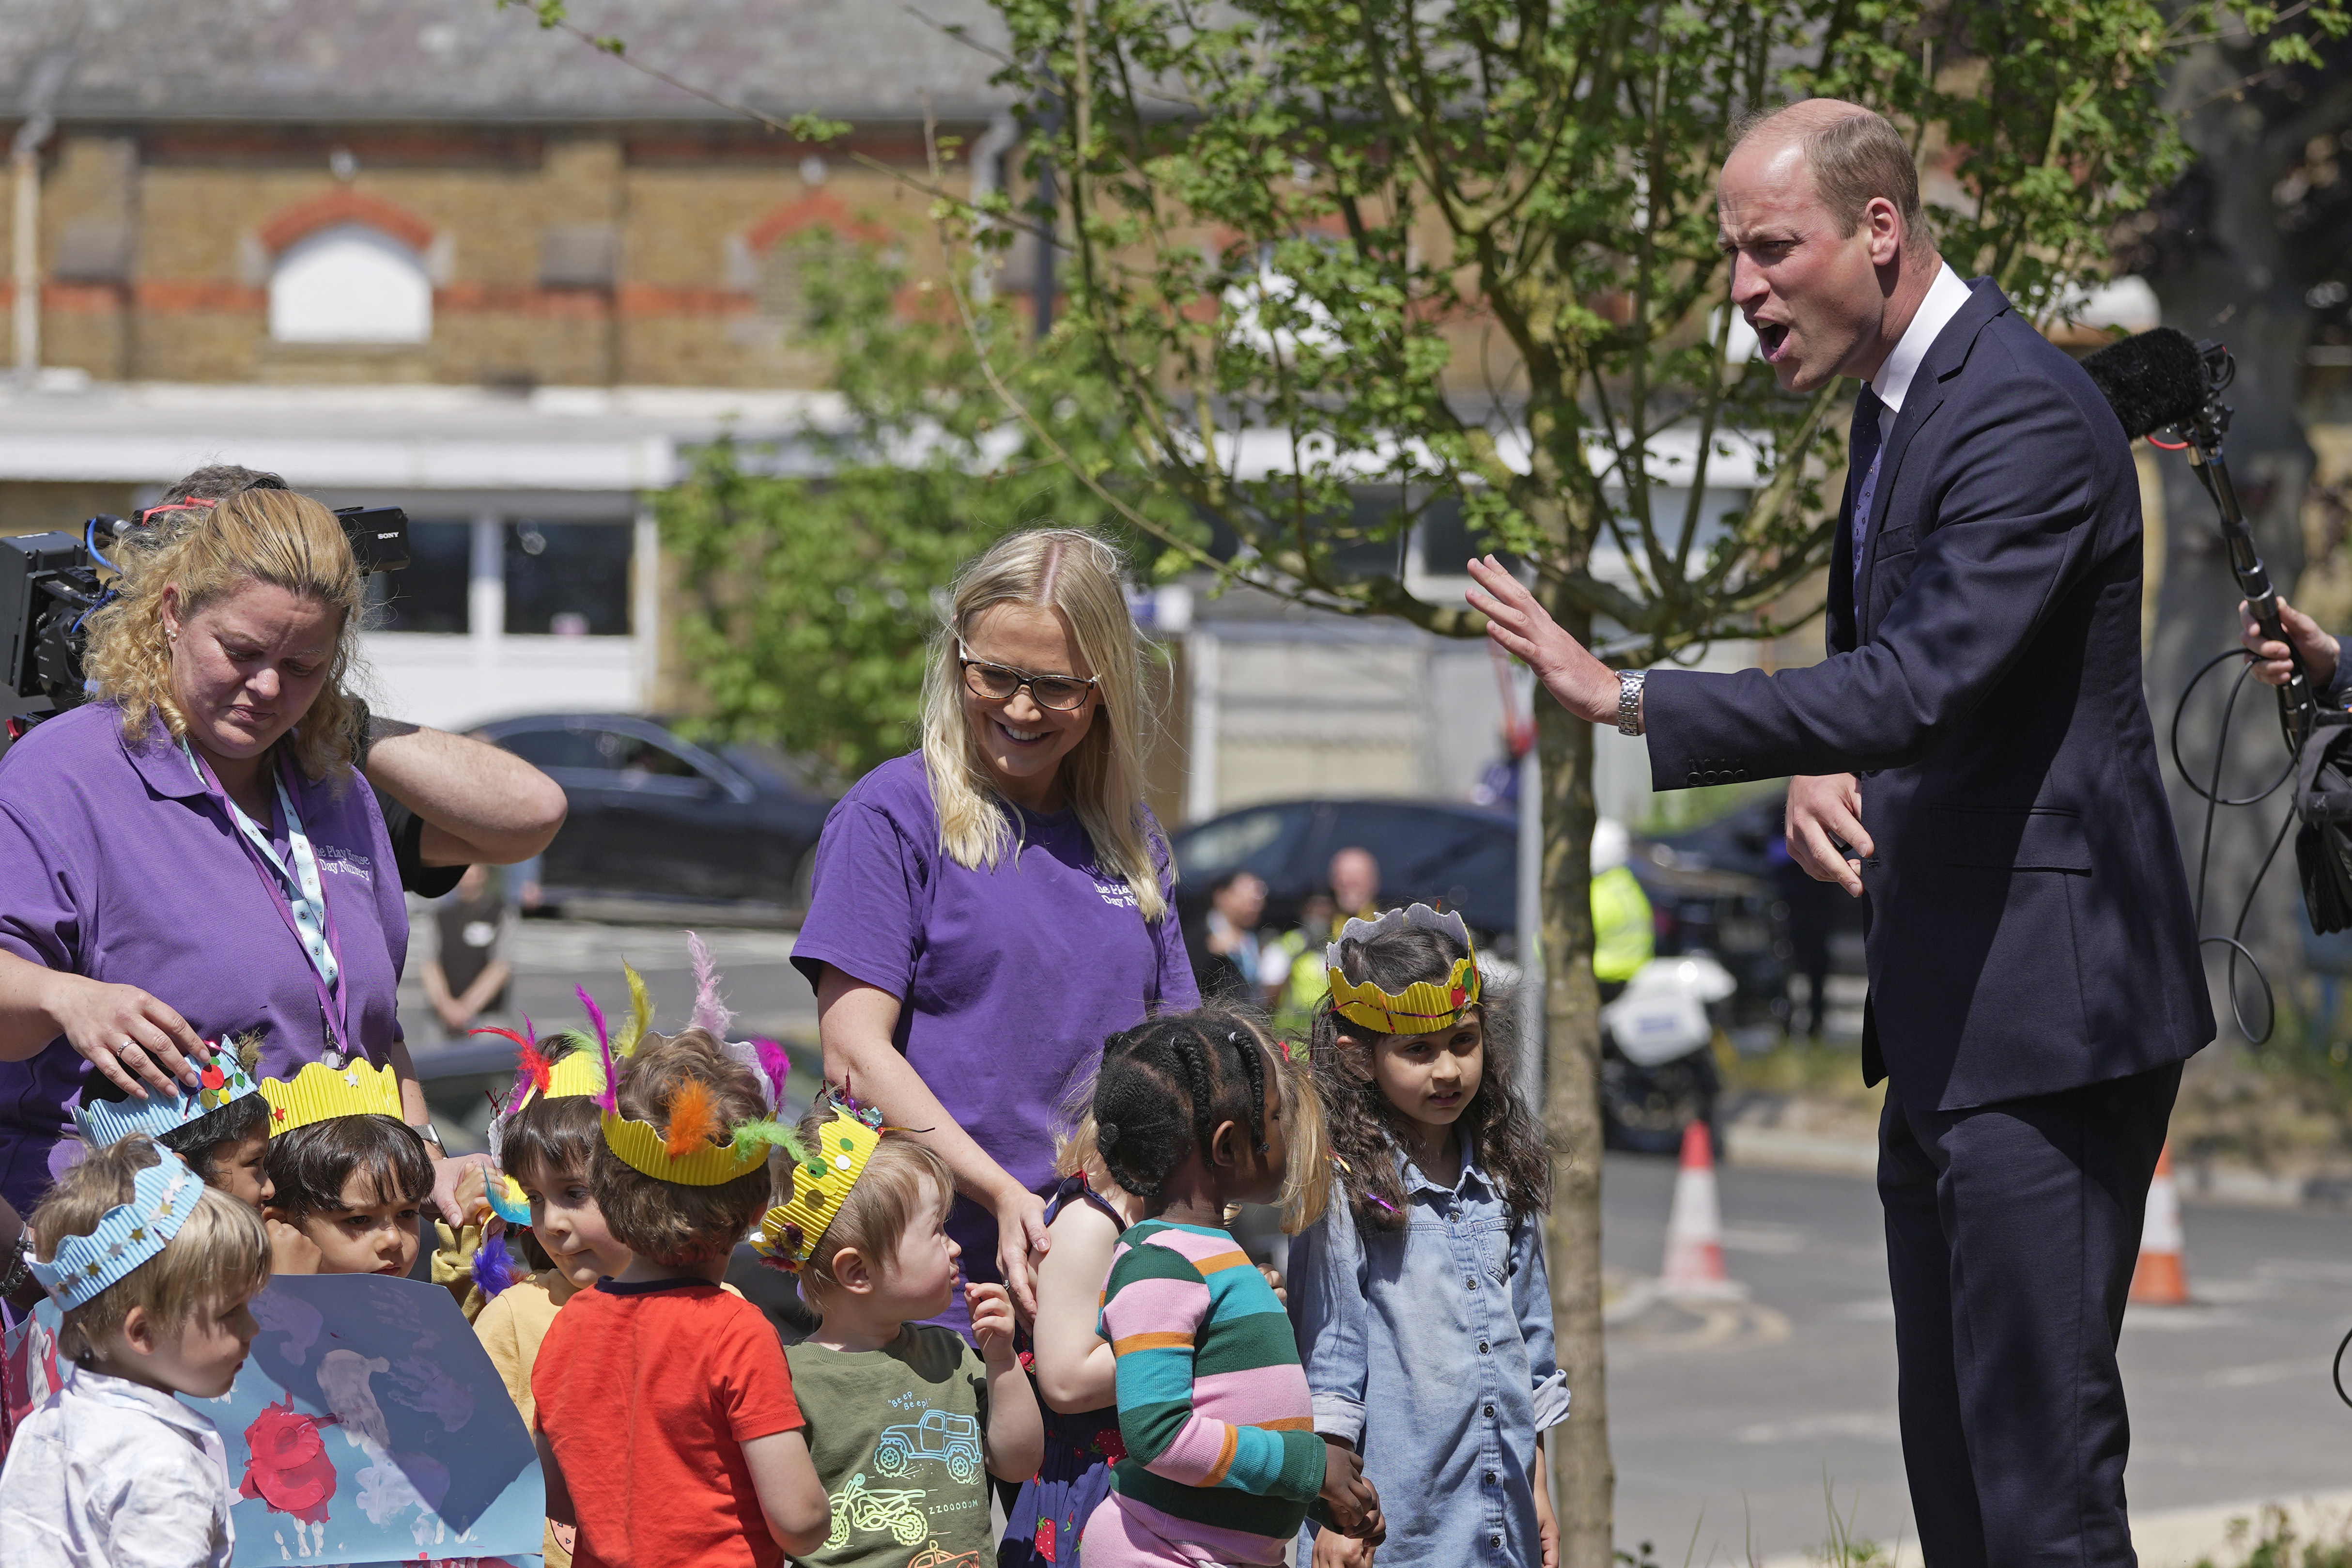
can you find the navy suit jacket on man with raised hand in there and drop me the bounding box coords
[1641,280,2213,1110]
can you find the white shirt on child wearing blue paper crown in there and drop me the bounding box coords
[0,1366,235,1568]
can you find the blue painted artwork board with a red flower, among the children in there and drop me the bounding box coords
[5,1274,546,1568]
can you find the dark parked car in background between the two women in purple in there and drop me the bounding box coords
[480,712,833,910]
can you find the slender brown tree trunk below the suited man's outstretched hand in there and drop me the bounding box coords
[1536,595,1616,1568]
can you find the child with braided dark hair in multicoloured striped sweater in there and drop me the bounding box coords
[1080,1009,1383,1568]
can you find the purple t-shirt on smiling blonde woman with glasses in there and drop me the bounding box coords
[792,752,1200,1326]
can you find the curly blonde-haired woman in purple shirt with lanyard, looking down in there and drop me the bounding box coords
[0,489,426,1211]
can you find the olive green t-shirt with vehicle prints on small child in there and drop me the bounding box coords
[783,1323,997,1568]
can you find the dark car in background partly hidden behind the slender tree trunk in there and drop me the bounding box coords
[1171,799,1788,1025]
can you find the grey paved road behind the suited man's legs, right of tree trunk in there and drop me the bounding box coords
[1602,1157,2352,1568]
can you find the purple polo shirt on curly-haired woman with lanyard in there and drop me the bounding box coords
[0,703,409,1211]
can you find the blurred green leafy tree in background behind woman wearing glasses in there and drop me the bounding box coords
[656,233,1167,778]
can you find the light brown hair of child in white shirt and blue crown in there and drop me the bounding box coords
[28,1133,270,1361]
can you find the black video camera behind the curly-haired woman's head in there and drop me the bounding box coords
[0,505,409,752]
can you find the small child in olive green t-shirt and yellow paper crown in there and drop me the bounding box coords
[755,1096,1044,1568]
